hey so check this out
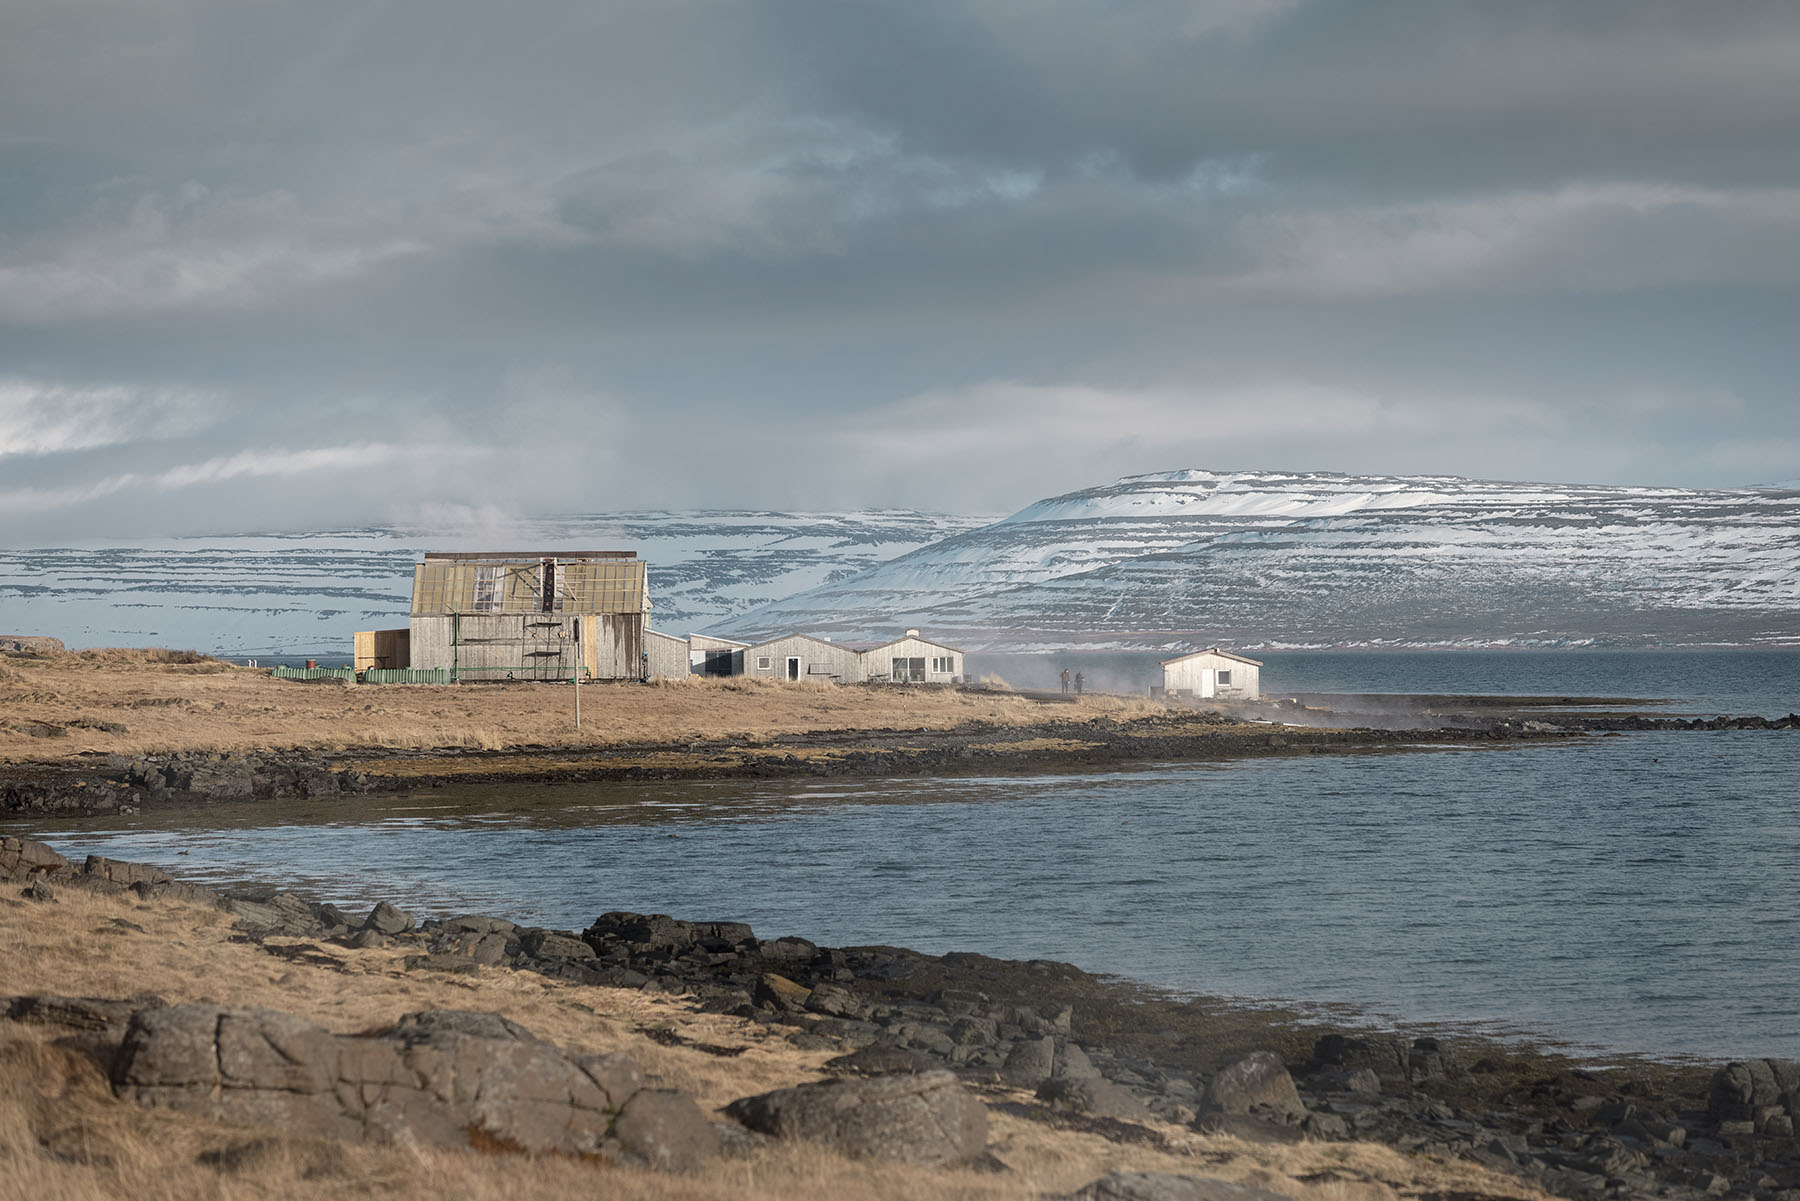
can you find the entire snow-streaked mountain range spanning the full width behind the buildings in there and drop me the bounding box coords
[0,470,1800,655]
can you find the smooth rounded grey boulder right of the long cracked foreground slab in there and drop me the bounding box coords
[725,1071,988,1165]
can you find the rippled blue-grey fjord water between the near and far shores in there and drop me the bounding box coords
[24,652,1800,1057]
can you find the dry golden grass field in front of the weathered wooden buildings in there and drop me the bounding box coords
[0,650,1156,762]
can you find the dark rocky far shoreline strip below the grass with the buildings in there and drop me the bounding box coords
[0,699,1800,817]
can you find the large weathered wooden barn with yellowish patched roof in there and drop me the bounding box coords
[405,551,650,681]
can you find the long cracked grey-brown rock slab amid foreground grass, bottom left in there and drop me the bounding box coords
[113,1005,718,1169]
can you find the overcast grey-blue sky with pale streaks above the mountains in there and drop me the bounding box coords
[0,0,1800,544]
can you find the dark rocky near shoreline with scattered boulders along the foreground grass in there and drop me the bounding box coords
[0,837,1800,1201]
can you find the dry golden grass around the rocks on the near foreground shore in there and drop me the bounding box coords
[0,889,1543,1201]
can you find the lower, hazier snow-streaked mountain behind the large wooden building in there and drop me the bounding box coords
[0,511,990,655]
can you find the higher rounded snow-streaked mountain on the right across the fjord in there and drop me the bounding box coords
[722,470,1800,650]
